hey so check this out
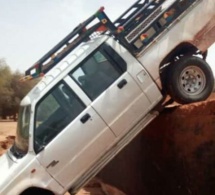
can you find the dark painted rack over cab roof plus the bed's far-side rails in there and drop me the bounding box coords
[22,0,174,78]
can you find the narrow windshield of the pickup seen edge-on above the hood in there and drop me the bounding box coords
[11,106,30,157]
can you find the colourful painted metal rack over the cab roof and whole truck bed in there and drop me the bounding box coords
[21,0,200,81]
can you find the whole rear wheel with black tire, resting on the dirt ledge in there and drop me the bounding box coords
[167,56,214,104]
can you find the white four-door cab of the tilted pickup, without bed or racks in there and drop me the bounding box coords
[1,36,162,194]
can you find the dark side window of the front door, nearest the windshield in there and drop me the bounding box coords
[34,82,85,152]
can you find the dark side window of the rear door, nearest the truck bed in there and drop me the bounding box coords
[70,45,126,100]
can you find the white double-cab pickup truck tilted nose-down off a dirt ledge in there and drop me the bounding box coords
[0,0,215,195]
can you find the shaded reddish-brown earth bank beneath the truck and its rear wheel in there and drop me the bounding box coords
[98,94,215,195]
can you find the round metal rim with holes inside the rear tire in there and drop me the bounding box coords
[180,66,206,95]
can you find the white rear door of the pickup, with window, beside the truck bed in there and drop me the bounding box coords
[70,44,151,136]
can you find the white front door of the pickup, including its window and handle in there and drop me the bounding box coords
[34,77,115,187]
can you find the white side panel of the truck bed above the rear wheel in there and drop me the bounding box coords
[137,0,215,92]
